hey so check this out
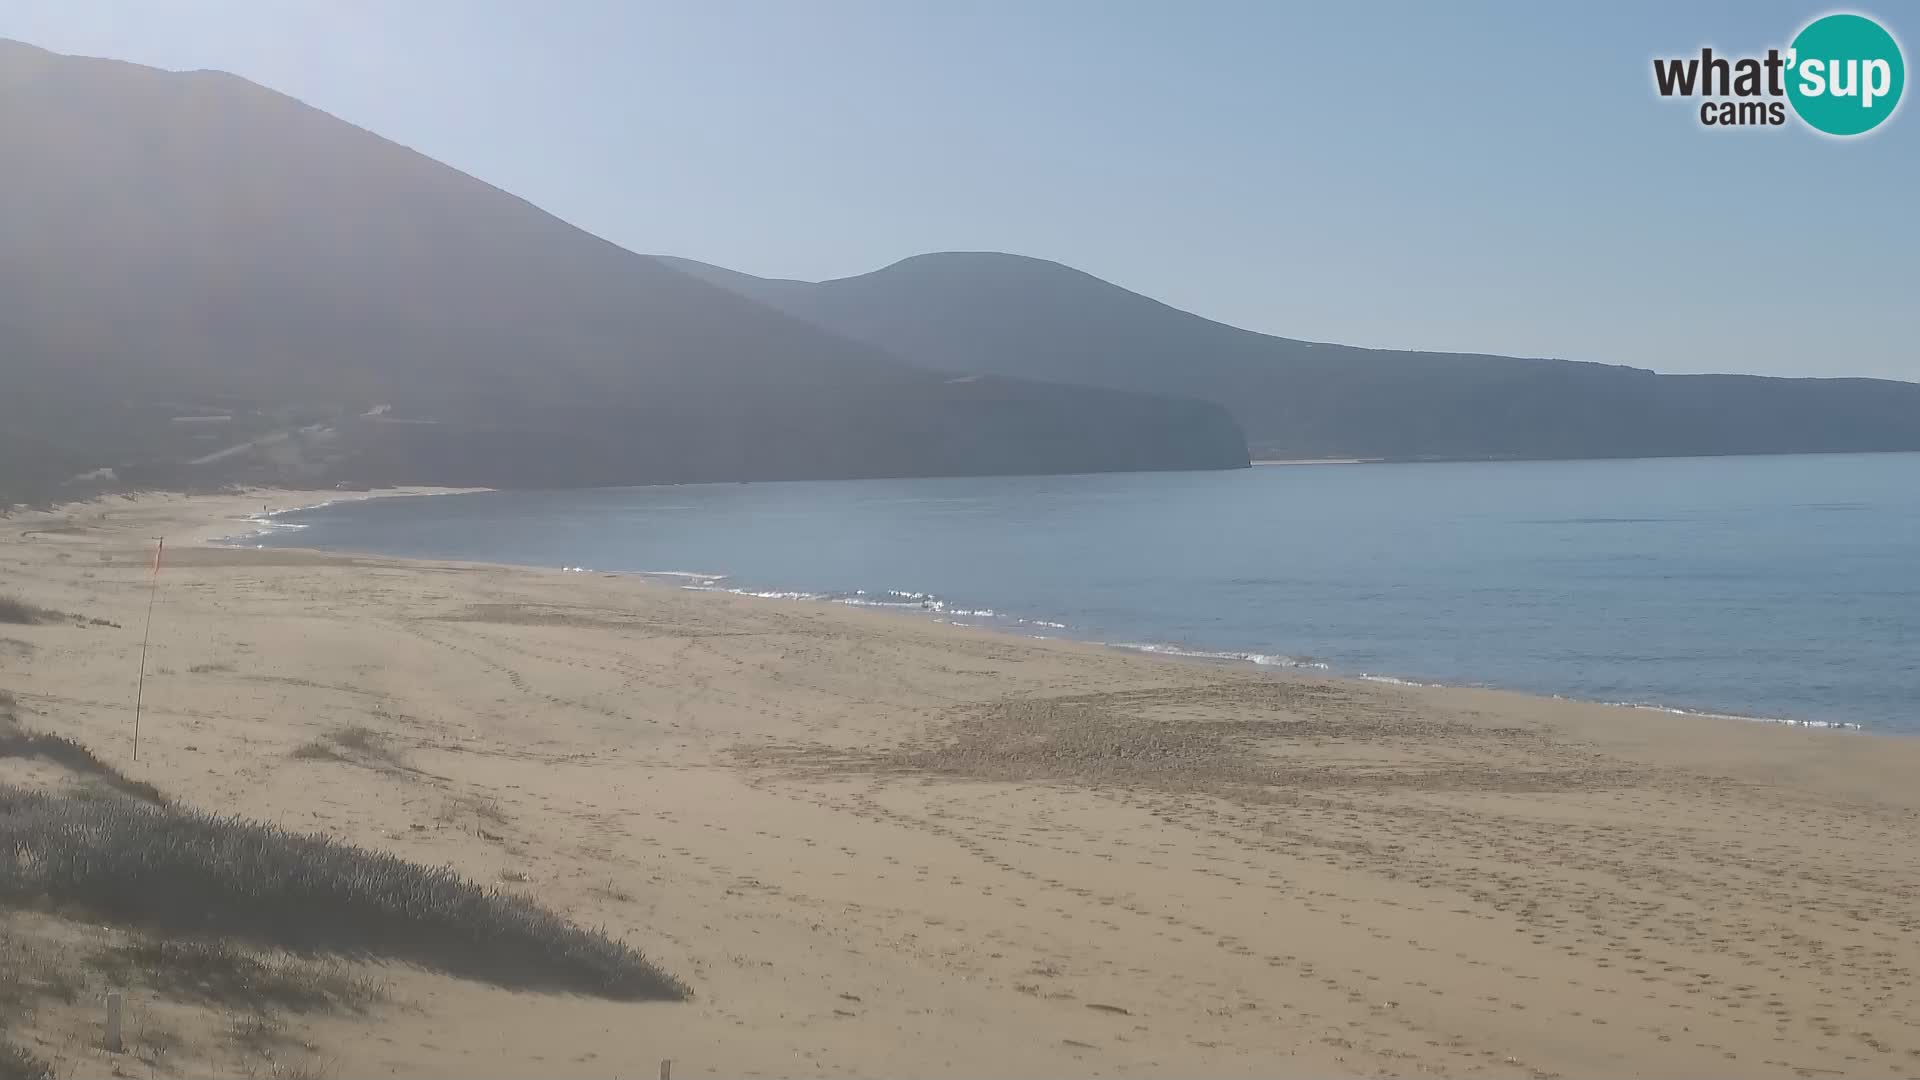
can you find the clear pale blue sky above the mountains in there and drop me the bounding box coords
[0,0,1920,380]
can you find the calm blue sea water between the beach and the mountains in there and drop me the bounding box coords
[248,454,1920,732]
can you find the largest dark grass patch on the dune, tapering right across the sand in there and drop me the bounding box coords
[0,786,687,1001]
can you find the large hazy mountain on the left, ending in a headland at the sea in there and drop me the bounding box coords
[0,40,1246,488]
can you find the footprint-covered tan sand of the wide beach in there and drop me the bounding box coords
[0,494,1920,1078]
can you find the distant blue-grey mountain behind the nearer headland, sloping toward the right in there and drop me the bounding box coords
[662,252,1920,459]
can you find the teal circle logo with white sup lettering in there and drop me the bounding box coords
[1788,15,1907,136]
